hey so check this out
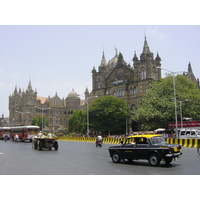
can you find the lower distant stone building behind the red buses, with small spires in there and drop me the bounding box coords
[9,81,87,131]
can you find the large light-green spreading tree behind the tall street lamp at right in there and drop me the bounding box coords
[132,75,200,130]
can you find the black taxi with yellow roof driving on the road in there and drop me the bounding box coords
[108,134,182,166]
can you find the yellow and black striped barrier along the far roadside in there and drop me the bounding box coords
[60,137,200,148]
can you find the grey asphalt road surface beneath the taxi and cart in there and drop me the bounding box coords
[0,140,200,175]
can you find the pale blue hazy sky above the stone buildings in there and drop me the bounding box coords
[0,1,200,117]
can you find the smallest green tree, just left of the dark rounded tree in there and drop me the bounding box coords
[68,110,87,134]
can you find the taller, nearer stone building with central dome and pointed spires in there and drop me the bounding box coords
[90,37,161,109]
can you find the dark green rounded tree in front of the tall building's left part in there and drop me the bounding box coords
[89,96,128,134]
